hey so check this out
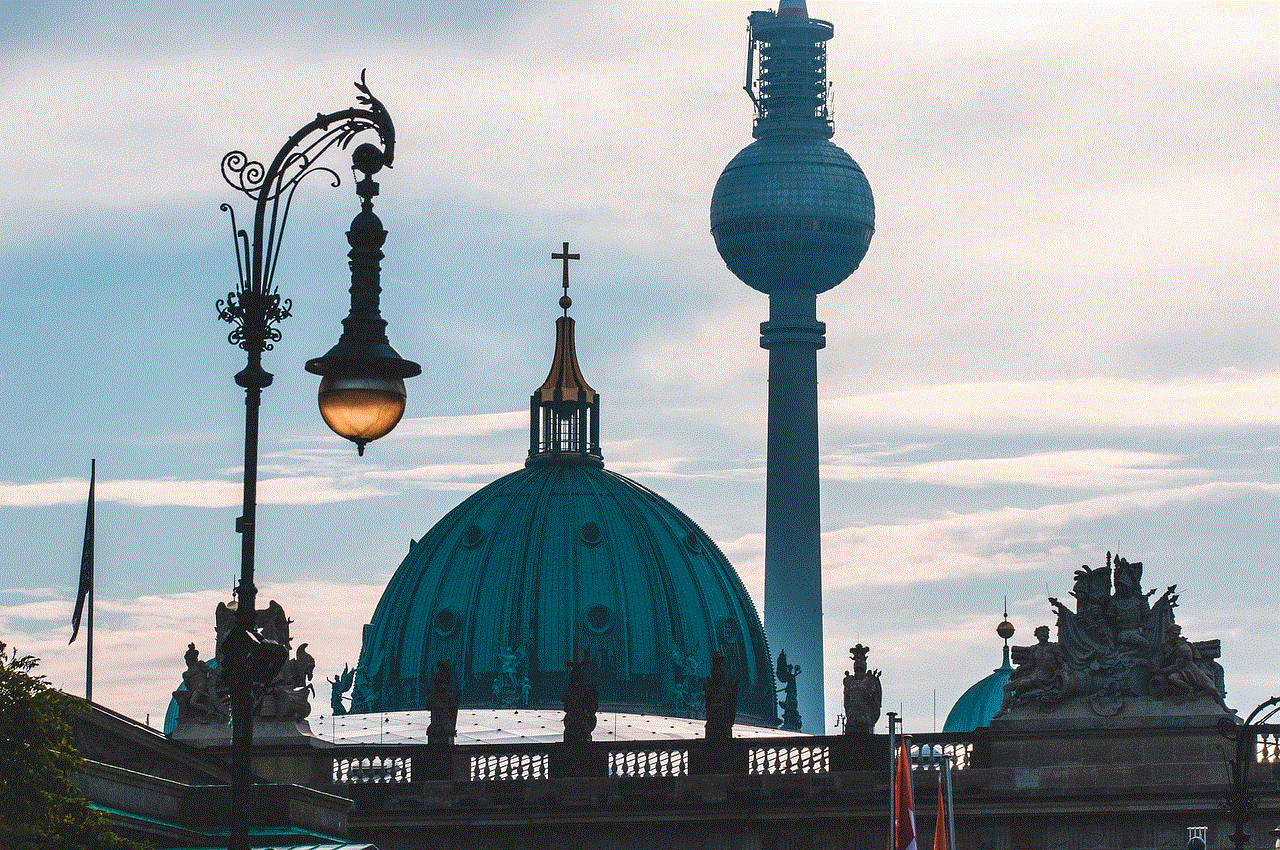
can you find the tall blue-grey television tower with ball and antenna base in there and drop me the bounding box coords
[710,0,876,734]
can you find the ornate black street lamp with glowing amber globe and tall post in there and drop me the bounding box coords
[218,73,421,850]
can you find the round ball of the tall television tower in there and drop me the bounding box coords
[710,136,876,293]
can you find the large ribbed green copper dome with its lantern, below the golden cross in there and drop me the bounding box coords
[352,279,776,726]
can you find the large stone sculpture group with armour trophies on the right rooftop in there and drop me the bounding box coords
[996,552,1230,717]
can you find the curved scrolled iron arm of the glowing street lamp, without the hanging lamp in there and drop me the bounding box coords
[218,72,396,368]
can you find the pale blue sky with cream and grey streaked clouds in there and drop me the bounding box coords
[0,0,1280,732]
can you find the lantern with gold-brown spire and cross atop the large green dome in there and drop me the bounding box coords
[525,242,604,466]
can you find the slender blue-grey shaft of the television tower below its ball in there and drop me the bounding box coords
[760,289,826,732]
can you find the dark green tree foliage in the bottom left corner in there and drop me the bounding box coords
[0,641,143,850]
